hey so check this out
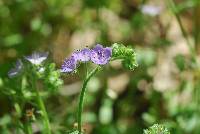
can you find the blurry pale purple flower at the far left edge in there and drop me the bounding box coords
[8,60,23,78]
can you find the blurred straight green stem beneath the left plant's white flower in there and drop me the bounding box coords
[33,78,51,134]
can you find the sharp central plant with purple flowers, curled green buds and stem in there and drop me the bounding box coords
[61,43,137,134]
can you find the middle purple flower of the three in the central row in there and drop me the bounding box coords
[72,48,91,62]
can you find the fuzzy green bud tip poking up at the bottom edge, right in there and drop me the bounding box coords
[144,124,170,134]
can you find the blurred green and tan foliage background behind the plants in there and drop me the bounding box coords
[0,0,200,134]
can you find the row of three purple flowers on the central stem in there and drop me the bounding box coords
[61,44,112,73]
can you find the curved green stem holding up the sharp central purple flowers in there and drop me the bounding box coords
[78,67,99,133]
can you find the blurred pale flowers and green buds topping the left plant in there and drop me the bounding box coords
[8,52,63,91]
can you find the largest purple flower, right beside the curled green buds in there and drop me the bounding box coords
[90,44,112,65]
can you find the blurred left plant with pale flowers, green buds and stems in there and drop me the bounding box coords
[8,52,63,134]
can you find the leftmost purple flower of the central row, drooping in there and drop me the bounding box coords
[61,56,77,73]
